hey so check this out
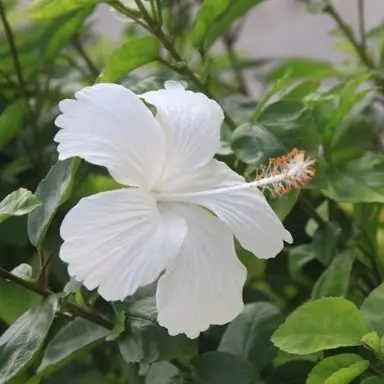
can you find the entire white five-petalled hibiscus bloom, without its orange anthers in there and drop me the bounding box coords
[55,81,294,338]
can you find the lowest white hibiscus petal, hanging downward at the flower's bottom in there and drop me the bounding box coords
[156,204,246,338]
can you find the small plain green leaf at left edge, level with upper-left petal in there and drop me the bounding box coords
[0,101,26,149]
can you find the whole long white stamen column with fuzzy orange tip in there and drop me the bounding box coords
[156,148,316,201]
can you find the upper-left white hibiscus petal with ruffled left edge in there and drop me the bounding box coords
[55,84,166,188]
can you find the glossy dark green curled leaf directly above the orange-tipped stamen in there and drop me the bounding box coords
[231,100,319,165]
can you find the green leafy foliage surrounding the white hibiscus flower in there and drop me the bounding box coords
[0,0,384,384]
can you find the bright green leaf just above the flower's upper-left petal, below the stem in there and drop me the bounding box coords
[99,36,160,83]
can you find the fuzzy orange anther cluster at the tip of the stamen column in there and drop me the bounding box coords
[255,149,315,197]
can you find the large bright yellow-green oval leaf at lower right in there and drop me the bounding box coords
[272,297,369,355]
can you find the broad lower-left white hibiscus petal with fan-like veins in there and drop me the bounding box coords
[60,188,187,301]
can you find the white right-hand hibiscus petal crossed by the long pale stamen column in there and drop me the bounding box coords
[161,159,292,259]
